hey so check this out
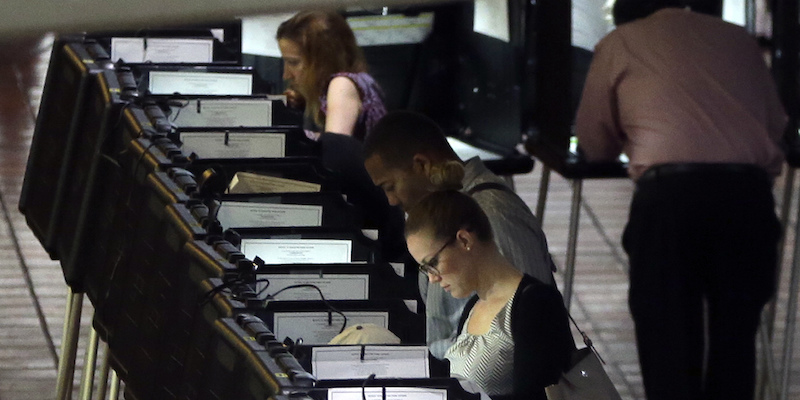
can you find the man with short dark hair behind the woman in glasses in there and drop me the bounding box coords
[364,111,554,358]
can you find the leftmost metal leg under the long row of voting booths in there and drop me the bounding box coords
[56,287,83,400]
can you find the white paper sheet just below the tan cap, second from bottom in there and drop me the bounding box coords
[311,346,430,379]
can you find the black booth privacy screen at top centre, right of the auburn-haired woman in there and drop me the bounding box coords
[354,1,532,159]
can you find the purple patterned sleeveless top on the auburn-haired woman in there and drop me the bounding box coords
[320,72,386,141]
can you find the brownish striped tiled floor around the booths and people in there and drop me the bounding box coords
[0,36,800,400]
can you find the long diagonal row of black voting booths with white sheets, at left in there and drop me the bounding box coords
[20,28,474,399]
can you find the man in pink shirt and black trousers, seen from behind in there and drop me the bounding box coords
[576,0,786,400]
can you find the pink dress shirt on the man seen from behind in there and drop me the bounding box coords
[576,8,786,180]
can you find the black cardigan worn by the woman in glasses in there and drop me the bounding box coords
[458,275,575,400]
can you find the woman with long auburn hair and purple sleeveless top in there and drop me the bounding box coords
[276,11,386,140]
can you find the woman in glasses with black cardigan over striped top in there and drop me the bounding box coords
[406,190,575,400]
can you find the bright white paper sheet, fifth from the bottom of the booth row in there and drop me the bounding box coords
[241,239,353,264]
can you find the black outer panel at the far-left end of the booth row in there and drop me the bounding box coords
[19,37,109,259]
